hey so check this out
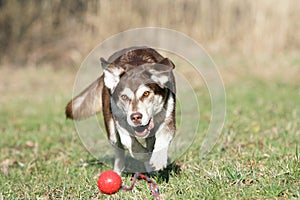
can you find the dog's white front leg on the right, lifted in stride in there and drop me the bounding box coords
[149,127,174,170]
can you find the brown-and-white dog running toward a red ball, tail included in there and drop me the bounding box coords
[66,47,176,174]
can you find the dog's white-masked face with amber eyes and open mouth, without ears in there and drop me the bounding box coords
[113,76,167,138]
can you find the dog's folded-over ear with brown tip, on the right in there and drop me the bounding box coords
[149,58,175,89]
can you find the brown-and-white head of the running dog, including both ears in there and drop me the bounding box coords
[102,58,175,138]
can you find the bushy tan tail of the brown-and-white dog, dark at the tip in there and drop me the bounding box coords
[66,76,103,120]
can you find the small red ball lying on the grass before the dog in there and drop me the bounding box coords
[98,170,122,194]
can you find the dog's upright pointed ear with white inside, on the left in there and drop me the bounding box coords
[100,58,125,93]
